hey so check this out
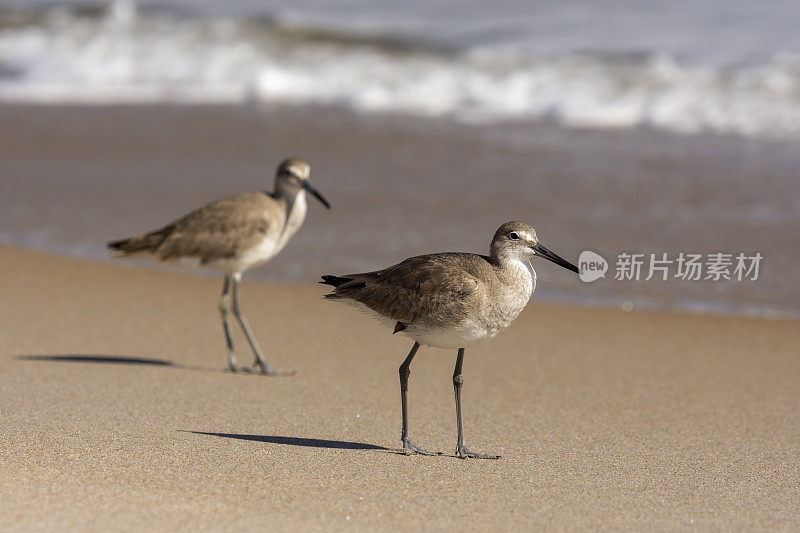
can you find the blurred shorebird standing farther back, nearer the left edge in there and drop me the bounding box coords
[108,159,330,375]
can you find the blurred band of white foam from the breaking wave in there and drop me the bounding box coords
[0,2,800,138]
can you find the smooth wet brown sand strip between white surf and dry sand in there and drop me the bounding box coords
[0,101,800,316]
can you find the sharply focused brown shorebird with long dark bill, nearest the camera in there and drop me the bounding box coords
[320,222,578,459]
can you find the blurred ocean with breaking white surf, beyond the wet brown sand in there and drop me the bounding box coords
[0,0,800,139]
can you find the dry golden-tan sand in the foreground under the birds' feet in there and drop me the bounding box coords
[0,248,800,531]
